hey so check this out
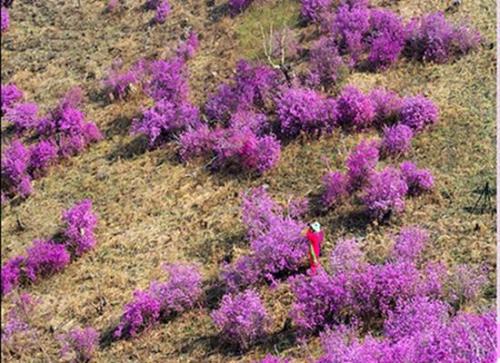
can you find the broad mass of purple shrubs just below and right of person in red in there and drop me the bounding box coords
[290,227,484,338]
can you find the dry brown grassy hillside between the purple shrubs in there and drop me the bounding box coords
[1,0,496,362]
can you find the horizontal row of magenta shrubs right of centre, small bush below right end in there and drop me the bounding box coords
[276,86,439,140]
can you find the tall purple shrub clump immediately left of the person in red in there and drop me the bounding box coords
[221,187,307,292]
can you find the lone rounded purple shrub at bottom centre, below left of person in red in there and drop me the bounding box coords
[211,290,270,349]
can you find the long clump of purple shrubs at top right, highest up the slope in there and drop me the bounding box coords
[324,6,481,70]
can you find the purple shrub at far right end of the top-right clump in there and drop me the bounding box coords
[405,12,481,63]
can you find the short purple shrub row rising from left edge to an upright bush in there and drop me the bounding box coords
[1,199,97,295]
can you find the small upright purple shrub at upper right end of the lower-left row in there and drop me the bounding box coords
[62,199,97,256]
